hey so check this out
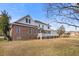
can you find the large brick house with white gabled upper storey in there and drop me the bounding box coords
[10,15,50,40]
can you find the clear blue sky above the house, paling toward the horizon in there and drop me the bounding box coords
[0,3,79,31]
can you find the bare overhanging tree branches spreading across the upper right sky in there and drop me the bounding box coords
[45,3,79,27]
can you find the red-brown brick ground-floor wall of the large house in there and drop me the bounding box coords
[11,25,38,40]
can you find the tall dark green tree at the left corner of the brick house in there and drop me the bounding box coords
[0,10,11,41]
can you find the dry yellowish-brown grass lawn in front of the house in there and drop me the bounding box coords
[0,38,79,56]
